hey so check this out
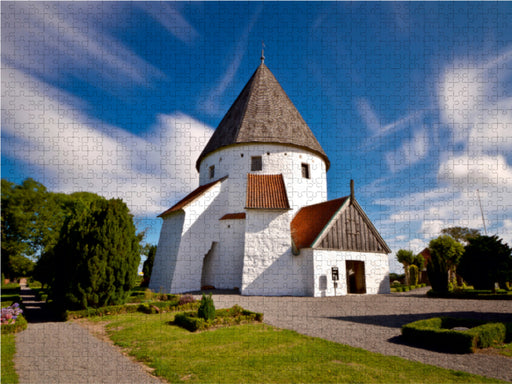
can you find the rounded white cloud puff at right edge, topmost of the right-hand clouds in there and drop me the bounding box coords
[438,49,512,152]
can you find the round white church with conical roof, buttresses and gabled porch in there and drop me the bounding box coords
[149,60,391,297]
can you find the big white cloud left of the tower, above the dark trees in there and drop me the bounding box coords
[2,68,213,216]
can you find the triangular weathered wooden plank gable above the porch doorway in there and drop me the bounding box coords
[313,199,391,253]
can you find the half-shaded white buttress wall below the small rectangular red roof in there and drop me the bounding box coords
[241,210,312,296]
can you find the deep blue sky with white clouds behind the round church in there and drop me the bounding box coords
[1,2,512,270]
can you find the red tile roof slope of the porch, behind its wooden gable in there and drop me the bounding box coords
[291,196,349,249]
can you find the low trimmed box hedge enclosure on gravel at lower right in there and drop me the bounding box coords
[402,317,512,353]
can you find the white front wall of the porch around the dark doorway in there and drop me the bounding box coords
[310,249,390,297]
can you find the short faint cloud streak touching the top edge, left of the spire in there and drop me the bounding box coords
[134,2,199,44]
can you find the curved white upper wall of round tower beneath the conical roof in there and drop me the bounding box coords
[199,144,327,213]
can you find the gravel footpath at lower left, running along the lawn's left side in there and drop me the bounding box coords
[14,286,164,384]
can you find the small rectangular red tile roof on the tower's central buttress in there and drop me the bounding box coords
[245,173,290,209]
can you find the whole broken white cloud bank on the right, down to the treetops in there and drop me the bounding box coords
[377,49,512,250]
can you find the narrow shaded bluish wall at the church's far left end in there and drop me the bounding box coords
[149,211,185,292]
